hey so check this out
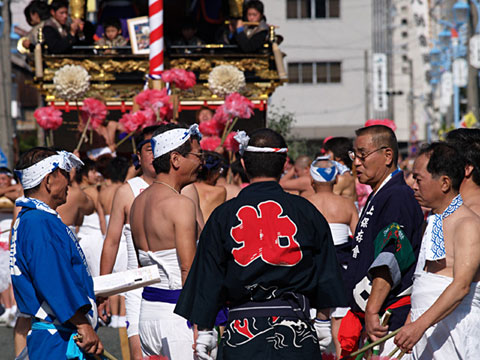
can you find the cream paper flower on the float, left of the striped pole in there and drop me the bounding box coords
[53,65,90,101]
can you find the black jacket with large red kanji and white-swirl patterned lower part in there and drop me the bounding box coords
[175,181,346,359]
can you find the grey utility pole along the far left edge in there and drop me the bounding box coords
[0,0,13,167]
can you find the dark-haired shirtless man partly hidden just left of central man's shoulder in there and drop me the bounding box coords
[195,151,227,221]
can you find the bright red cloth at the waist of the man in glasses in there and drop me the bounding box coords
[338,295,411,357]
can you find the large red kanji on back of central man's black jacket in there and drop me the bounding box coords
[230,200,302,266]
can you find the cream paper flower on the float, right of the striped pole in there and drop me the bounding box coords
[208,65,245,96]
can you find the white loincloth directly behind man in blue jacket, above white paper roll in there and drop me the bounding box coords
[77,212,104,277]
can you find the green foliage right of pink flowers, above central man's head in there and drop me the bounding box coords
[267,105,309,159]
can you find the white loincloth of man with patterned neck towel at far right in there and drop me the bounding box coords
[411,271,480,360]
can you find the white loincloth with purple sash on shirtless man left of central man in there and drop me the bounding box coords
[138,249,193,360]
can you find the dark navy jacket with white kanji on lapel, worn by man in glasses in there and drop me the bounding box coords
[345,171,423,331]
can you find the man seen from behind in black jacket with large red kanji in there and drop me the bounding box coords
[175,129,346,360]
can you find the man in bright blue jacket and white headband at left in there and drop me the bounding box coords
[10,148,103,360]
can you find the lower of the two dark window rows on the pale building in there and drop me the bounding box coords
[288,61,342,84]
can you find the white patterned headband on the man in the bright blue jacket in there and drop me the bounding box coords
[15,151,83,190]
